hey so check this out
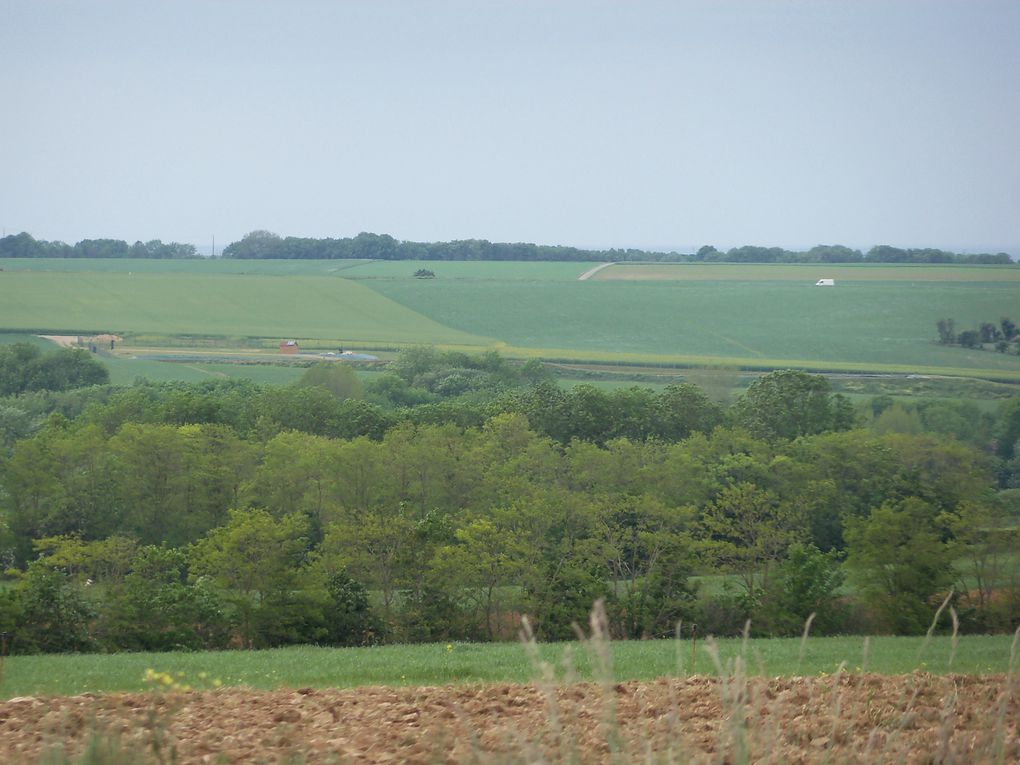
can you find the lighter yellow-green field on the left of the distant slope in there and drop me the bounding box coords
[0,271,490,345]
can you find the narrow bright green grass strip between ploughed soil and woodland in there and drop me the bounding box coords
[0,635,1012,699]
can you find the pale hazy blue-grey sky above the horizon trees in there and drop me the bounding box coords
[0,0,1020,256]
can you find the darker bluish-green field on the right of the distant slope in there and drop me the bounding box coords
[366,279,1020,377]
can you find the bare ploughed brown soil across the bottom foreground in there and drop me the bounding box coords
[0,674,1020,765]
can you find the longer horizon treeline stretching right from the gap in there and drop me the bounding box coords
[223,231,1013,265]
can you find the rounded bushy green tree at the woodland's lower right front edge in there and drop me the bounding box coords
[846,497,956,634]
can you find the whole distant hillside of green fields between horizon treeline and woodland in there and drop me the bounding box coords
[0,260,1020,380]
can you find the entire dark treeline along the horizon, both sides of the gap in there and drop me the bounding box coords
[0,231,1013,265]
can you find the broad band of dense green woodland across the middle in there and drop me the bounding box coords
[0,347,1020,652]
